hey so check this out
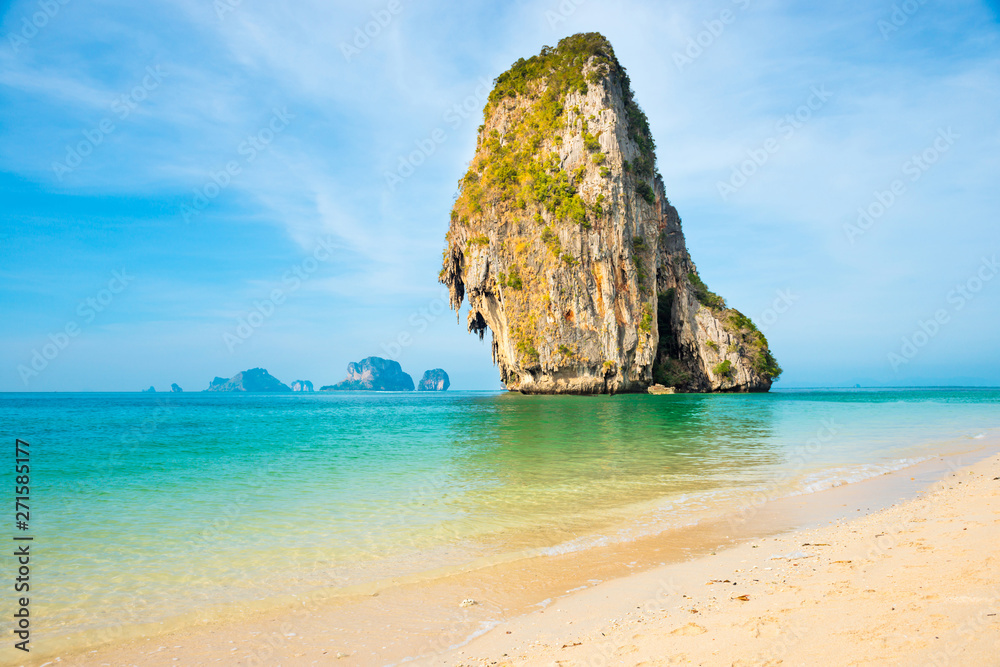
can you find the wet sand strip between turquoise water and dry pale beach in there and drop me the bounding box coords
[24,435,1000,665]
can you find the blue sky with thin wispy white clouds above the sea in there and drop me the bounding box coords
[0,0,1000,391]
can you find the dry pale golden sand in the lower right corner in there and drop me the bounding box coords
[420,448,1000,666]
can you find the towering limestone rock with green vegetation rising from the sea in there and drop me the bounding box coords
[439,33,780,394]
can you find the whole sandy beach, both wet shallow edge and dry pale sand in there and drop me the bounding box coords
[47,443,1000,666]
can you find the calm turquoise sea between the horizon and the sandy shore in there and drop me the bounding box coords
[0,389,1000,646]
